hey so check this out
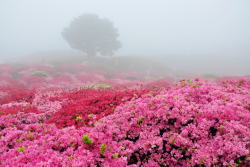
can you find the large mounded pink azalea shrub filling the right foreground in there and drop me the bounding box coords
[100,77,250,166]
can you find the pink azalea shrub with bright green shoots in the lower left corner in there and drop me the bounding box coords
[0,116,133,167]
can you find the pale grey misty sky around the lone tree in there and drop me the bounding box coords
[0,0,250,60]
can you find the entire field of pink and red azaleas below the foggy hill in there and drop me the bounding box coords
[0,63,250,167]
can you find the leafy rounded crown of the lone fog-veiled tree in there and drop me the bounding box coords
[62,14,122,57]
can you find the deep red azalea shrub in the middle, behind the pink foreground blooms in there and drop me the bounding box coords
[46,89,148,128]
